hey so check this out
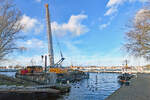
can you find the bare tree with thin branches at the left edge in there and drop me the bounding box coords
[0,0,22,60]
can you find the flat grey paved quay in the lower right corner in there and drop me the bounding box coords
[105,74,150,100]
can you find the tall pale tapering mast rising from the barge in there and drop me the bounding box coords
[45,4,54,67]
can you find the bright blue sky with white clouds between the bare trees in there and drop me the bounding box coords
[2,0,149,66]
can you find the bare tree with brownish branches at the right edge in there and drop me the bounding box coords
[124,8,150,58]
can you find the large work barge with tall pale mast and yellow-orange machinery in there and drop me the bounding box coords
[16,4,87,84]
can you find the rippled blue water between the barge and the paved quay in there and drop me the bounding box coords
[0,73,120,100]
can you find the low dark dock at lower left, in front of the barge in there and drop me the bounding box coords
[0,74,70,94]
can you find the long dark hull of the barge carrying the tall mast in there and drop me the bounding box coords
[16,71,89,85]
